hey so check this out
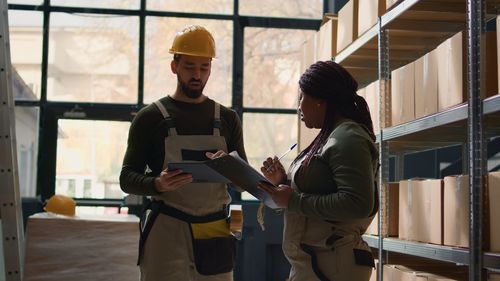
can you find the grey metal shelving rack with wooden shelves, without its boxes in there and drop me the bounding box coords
[333,0,500,280]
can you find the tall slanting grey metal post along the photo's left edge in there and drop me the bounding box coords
[0,0,24,281]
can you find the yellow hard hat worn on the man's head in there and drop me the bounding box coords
[168,25,215,58]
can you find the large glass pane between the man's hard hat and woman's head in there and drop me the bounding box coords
[243,28,315,109]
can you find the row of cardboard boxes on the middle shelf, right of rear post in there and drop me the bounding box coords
[391,32,499,126]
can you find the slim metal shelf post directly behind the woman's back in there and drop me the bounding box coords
[375,17,391,280]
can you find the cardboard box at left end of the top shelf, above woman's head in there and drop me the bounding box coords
[337,0,359,53]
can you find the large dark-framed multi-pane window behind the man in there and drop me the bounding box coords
[8,0,326,206]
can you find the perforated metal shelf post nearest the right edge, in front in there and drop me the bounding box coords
[467,0,486,281]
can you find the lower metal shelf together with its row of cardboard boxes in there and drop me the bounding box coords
[363,172,500,271]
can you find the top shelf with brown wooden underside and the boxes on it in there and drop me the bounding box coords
[332,0,496,88]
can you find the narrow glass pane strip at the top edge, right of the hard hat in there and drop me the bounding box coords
[239,0,323,19]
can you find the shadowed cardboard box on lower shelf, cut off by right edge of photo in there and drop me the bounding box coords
[488,172,500,252]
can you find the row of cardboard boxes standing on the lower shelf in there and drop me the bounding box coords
[399,172,500,249]
